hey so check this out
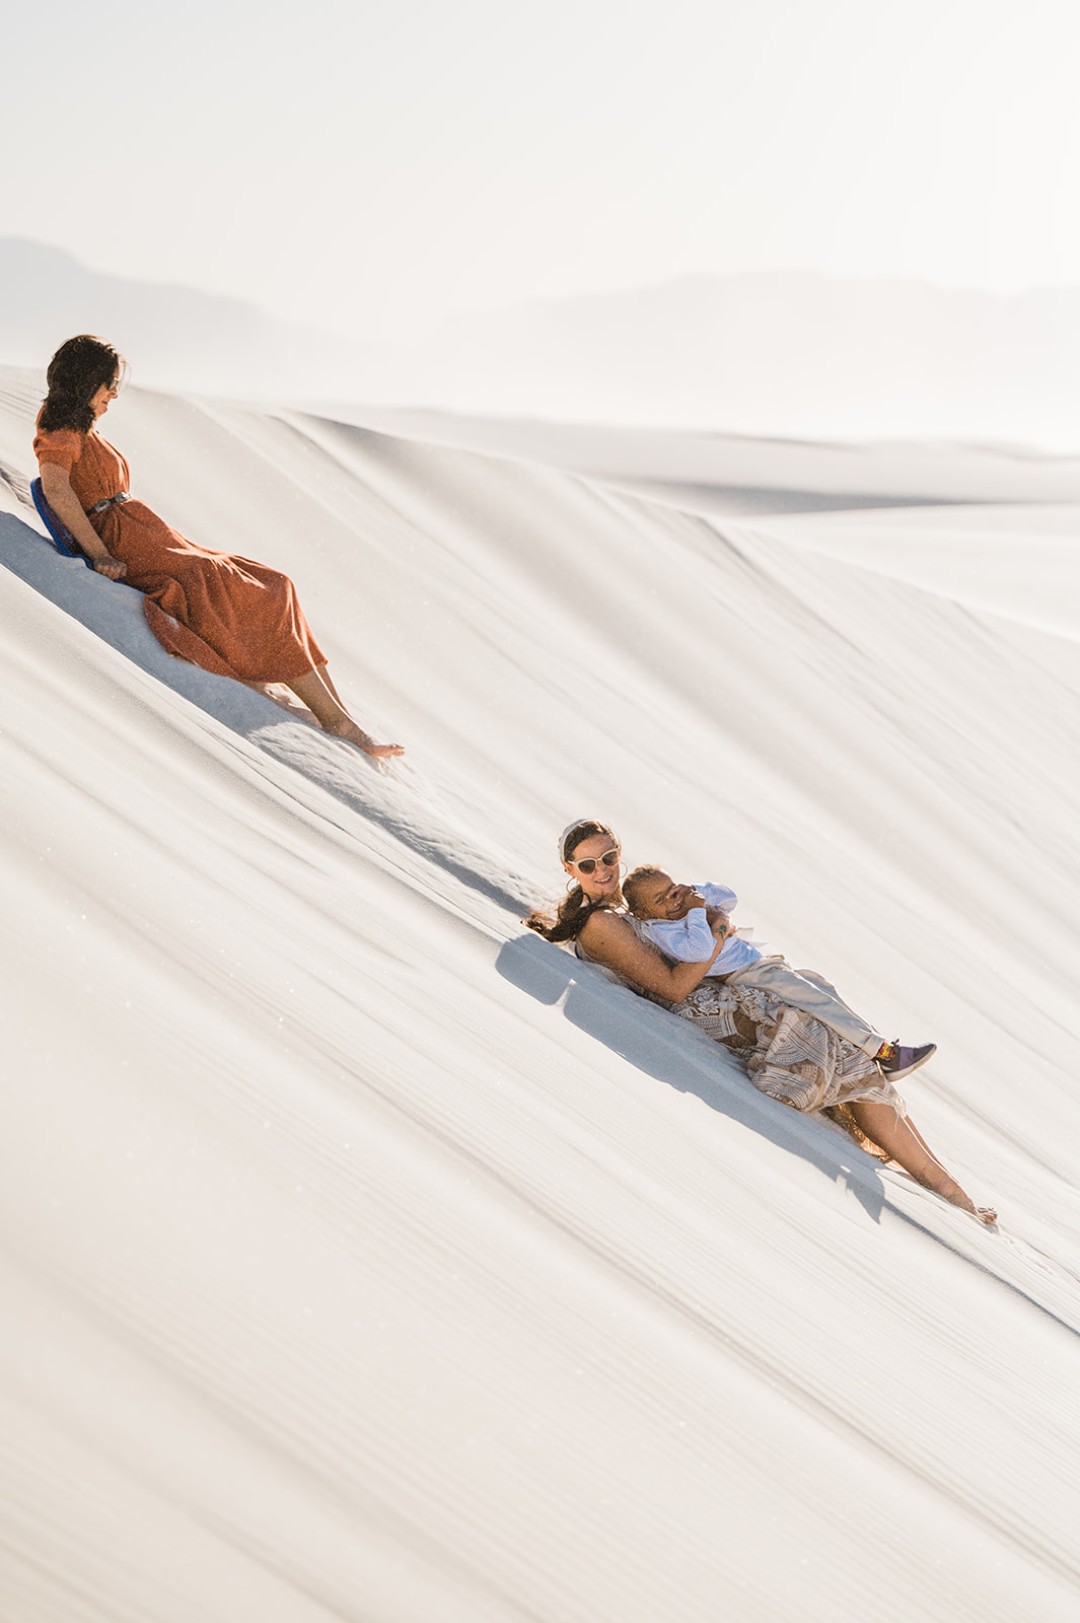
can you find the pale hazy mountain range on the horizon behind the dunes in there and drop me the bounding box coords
[0,239,1080,451]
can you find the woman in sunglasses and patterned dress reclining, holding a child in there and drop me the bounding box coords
[526,818,997,1224]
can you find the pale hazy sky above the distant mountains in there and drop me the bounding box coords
[0,0,1080,338]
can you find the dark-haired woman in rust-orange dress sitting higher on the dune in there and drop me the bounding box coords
[34,334,404,756]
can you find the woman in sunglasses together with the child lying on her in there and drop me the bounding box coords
[526,818,997,1224]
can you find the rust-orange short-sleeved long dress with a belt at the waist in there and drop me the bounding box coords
[34,428,326,682]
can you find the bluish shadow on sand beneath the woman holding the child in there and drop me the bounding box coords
[495,933,887,1222]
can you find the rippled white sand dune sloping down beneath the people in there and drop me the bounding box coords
[0,373,1080,1623]
